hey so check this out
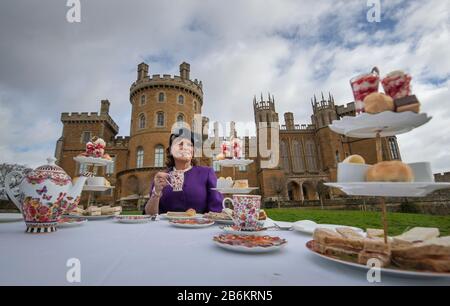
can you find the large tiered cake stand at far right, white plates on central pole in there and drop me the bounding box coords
[325,111,450,243]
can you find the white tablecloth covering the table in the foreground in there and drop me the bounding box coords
[0,219,450,286]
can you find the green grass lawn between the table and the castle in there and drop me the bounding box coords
[123,208,450,236]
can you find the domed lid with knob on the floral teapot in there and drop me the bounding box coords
[27,157,72,186]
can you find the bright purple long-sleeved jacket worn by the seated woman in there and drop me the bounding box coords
[144,166,223,214]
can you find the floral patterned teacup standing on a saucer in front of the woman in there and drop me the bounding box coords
[222,194,261,231]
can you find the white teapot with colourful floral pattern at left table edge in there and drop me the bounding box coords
[5,158,87,233]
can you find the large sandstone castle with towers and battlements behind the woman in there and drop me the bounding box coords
[55,62,401,204]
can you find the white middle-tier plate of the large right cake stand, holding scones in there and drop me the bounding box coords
[325,182,450,197]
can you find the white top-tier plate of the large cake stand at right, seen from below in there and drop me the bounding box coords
[329,111,431,138]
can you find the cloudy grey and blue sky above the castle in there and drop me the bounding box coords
[0,0,450,172]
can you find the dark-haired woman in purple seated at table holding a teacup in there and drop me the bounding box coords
[144,129,223,215]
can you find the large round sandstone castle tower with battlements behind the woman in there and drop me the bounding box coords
[127,62,203,169]
